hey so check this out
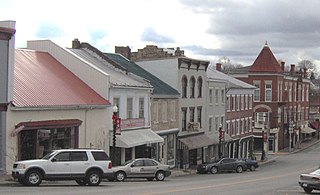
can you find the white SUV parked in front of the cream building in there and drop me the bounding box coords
[12,149,113,186]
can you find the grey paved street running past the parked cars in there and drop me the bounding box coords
[0,140,320,195]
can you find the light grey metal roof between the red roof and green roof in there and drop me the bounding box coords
[69,49,152,88]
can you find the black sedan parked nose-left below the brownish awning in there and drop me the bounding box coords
[197,158,247,174]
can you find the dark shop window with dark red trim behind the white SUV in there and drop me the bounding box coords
[13,119,82,160]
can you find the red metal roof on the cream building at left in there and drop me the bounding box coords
[13,49,110,107]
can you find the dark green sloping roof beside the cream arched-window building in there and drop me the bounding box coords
[105,53,180,96]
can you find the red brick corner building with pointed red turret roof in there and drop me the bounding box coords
[230,43,313,152]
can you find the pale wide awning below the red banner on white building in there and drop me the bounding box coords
[116,129,164,148]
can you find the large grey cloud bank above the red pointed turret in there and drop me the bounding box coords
[180,0,320,63]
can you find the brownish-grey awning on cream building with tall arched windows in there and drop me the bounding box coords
[179,134,215,150]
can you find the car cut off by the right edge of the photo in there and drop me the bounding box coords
[299,169,320,194]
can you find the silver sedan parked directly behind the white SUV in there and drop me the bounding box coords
[112,158,171,181]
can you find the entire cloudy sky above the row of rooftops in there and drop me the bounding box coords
[0,0,320,69]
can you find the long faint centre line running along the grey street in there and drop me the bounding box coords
[142,167,317,195]
